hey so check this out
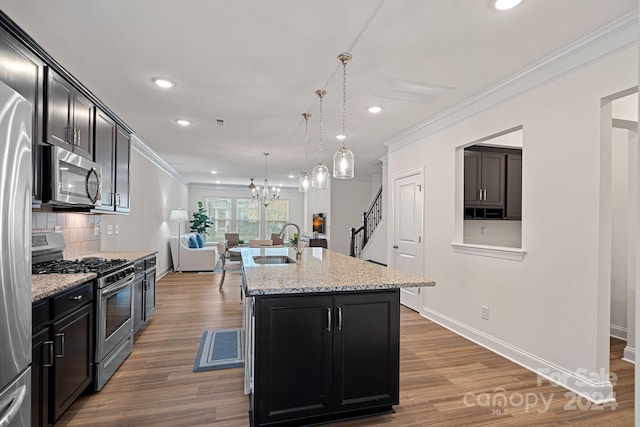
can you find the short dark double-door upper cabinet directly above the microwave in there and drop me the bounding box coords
[46,68,95,160]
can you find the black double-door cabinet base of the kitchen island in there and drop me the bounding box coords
[251,289,400,427]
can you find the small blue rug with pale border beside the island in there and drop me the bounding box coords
[193,328,244,372]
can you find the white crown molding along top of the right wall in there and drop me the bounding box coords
[384,9,639,152]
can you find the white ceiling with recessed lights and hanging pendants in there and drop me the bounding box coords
[1,0,638,186]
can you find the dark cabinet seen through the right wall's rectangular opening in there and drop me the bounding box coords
[464,146,522,219]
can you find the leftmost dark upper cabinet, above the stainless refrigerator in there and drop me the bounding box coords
[0,22,45,204]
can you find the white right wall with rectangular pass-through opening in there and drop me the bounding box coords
[387,46,638,400]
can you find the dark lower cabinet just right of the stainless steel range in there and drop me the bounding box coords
[133,255,156,334]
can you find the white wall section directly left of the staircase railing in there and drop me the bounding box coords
[331,179,380,255]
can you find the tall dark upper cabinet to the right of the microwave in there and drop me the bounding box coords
[94,109,131,213]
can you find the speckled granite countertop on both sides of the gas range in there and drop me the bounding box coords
[31,251,158,302]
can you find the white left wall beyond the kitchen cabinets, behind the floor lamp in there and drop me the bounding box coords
[100,139,188,276]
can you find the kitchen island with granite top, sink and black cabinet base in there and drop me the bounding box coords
[241,248,435,427]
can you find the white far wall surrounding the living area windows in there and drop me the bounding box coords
[184,184,310,242]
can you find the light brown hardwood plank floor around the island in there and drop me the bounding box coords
[56,273,634,427]
